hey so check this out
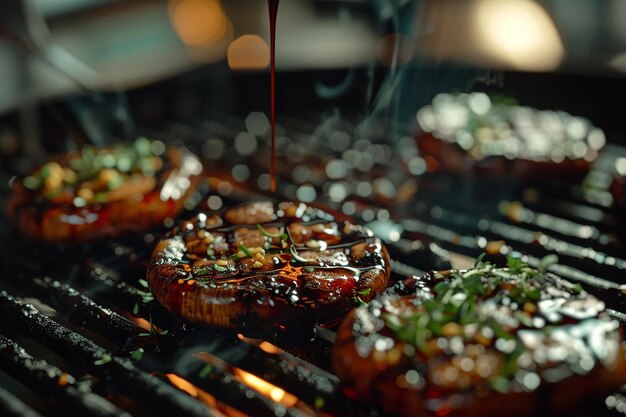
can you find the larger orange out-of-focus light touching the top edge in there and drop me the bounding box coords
[169,0,230,47]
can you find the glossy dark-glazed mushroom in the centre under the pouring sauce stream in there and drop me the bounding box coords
[147,202,390,327]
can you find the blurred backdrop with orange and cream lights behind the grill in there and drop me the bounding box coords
[0,0,626,140]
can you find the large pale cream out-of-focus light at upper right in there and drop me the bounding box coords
[418,0,564,71]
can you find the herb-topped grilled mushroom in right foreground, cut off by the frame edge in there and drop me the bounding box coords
[333,261,626,416]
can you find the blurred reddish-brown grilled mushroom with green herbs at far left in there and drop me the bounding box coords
[5,138,202,243]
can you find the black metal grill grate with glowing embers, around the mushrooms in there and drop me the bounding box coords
[0,111,626,416]
